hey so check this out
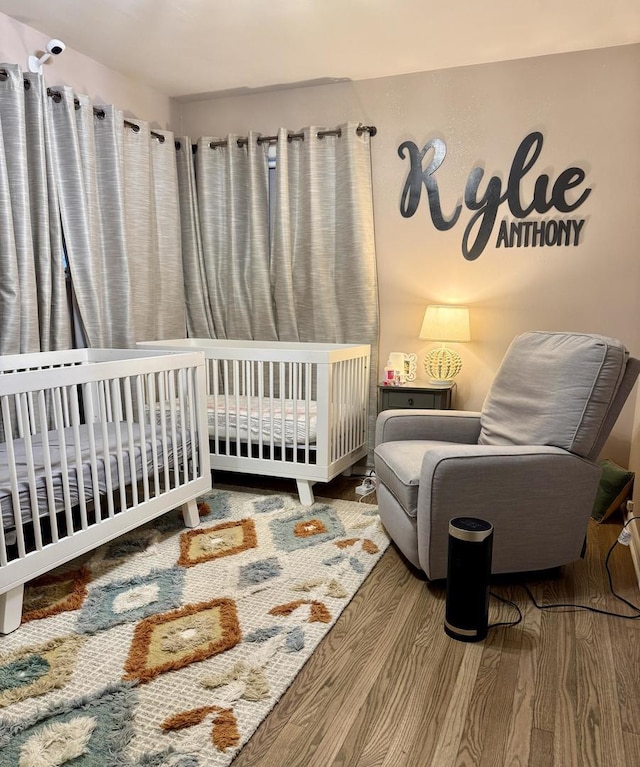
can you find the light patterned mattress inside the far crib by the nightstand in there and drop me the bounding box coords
[207,394,318,446]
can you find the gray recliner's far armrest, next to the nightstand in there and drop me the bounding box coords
[375,410,480,445]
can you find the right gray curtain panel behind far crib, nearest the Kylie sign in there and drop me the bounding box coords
[271,123,379,447]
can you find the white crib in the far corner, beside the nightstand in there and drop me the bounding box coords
[138,338,371,505]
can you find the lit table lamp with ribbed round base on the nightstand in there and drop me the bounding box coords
[418,305,471,385]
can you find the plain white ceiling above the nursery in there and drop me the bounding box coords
[0,0,640,97]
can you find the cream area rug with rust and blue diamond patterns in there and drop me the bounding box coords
[0,488,389,767]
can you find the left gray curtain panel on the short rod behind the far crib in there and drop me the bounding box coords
[179,133,277,341]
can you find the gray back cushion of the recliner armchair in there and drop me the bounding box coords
[478,331,628,456]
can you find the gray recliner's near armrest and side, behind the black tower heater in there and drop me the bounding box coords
[417,445,601,579]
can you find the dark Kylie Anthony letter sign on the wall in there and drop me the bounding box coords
[398,131,591,261]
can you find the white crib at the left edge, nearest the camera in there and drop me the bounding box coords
[0,349,211,634]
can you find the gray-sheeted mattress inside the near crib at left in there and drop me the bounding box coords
[0,422,190,531]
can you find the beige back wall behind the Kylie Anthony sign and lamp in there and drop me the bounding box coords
[180,45,640,463]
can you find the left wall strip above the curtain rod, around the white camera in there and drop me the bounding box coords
[0,13,177,130]
